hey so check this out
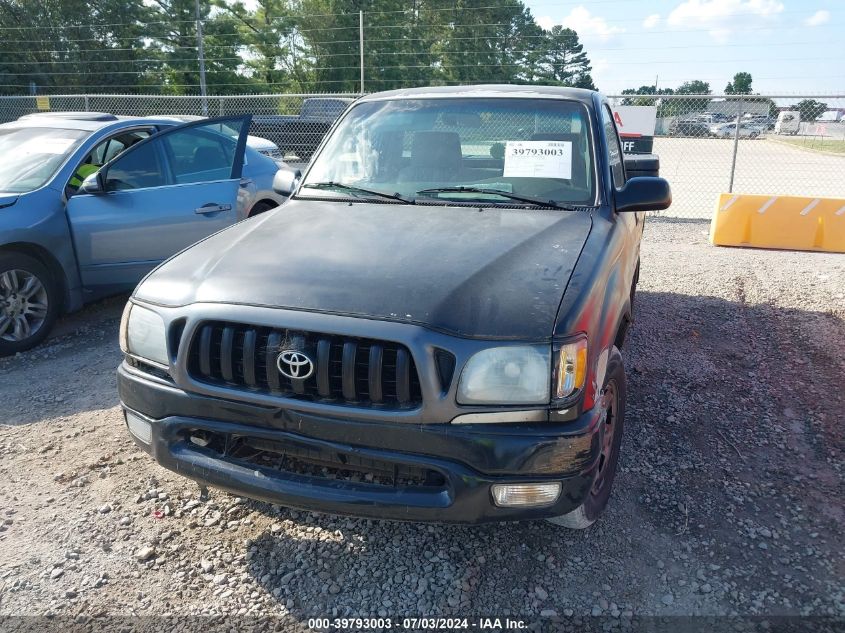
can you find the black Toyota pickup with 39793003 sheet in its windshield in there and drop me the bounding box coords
[118,86,671,528]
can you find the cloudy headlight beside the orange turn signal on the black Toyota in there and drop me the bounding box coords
[458,345,551,404]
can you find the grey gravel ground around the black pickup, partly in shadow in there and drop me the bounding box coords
[0,219,845,630]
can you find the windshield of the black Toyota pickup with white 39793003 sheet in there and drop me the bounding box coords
[298,98,595,205]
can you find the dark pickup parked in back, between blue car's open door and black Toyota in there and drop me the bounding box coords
[250,97,355,162]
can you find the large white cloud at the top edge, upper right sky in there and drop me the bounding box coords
[666,0,783,42]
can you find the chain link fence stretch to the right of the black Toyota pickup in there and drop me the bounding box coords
[610,95,845,218]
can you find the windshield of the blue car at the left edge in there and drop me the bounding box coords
[0,127,90,193]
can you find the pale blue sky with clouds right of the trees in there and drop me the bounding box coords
[523,0,845,95]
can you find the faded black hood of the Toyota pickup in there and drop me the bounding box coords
[135,199,592,340]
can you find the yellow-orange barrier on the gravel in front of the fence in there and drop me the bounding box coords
[710,193,845,253]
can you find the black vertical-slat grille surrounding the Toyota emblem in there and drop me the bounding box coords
[188,321,422,409]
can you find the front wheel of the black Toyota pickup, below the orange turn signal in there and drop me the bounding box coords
[549,347,625,530]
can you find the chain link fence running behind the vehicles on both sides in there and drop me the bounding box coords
[0,94,845,218]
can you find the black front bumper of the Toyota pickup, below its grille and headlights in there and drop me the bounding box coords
[118,365,600,523]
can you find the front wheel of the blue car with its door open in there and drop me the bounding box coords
[0,253,61,356]
